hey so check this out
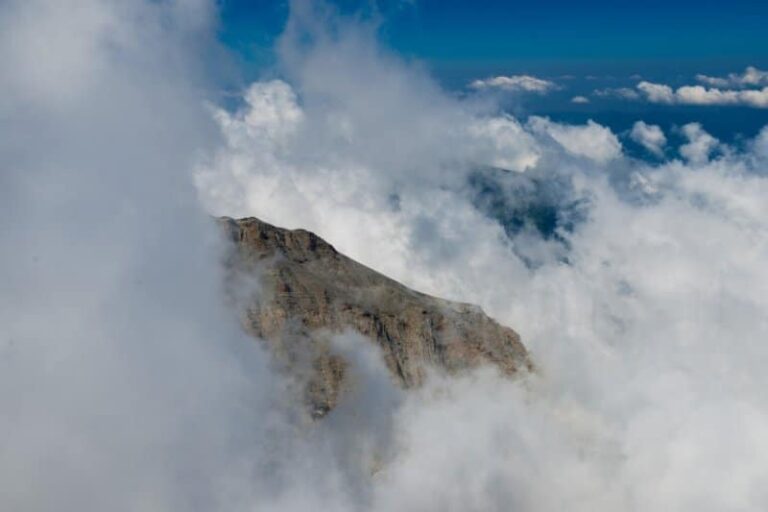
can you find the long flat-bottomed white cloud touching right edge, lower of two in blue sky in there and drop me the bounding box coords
[637,82,768,108]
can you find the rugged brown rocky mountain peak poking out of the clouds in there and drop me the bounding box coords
[219,218,531,416]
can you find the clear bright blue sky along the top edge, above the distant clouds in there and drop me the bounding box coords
[222,0,768,75]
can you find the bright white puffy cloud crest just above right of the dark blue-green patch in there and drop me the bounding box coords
[528,116,621,164]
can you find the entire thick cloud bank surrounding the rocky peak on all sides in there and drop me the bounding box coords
[0,0,768,512]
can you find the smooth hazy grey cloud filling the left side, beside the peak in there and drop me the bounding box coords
[0,0,294,511]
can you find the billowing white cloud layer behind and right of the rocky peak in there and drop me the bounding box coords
[197,4,768,511]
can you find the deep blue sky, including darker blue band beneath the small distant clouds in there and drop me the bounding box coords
[221,0,768,138]
